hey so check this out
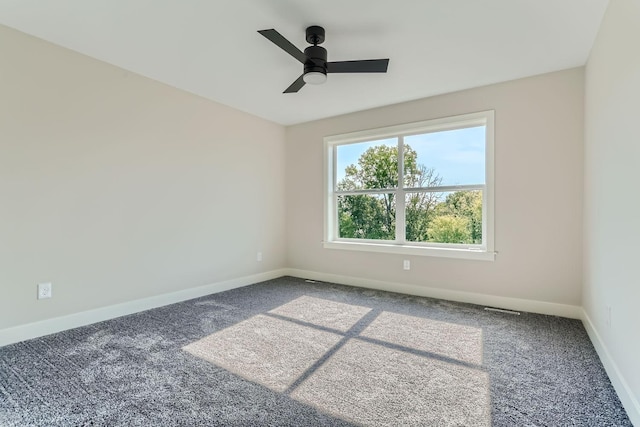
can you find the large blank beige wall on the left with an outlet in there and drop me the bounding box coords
[0,26,285,330]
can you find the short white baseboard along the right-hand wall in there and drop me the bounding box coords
[582,309,640,426]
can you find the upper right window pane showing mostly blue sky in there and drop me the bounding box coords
[404,126,485,187]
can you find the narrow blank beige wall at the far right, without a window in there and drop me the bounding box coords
[583,0,640,425]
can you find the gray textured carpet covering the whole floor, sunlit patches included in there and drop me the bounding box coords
[0,277,631,427]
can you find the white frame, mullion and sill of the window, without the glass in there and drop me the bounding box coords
[323,110,495,261]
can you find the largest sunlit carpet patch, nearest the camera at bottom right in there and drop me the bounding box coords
[291,339,491,427]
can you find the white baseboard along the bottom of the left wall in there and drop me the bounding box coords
[0,270,287,347]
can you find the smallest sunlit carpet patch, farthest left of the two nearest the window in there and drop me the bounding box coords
[269,296,371,332]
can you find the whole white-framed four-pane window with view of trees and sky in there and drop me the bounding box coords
[324,111,494,260]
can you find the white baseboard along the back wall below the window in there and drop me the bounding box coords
[285,268,582,319]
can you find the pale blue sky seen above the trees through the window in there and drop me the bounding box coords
[338,126,485,185]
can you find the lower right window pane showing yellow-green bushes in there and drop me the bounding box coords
[405,190,482,244]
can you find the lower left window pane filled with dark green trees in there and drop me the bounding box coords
[338,194,396,240]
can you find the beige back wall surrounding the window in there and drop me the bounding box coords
[286,68,583,305]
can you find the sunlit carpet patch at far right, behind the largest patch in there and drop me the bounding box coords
[360,311,482,365]
